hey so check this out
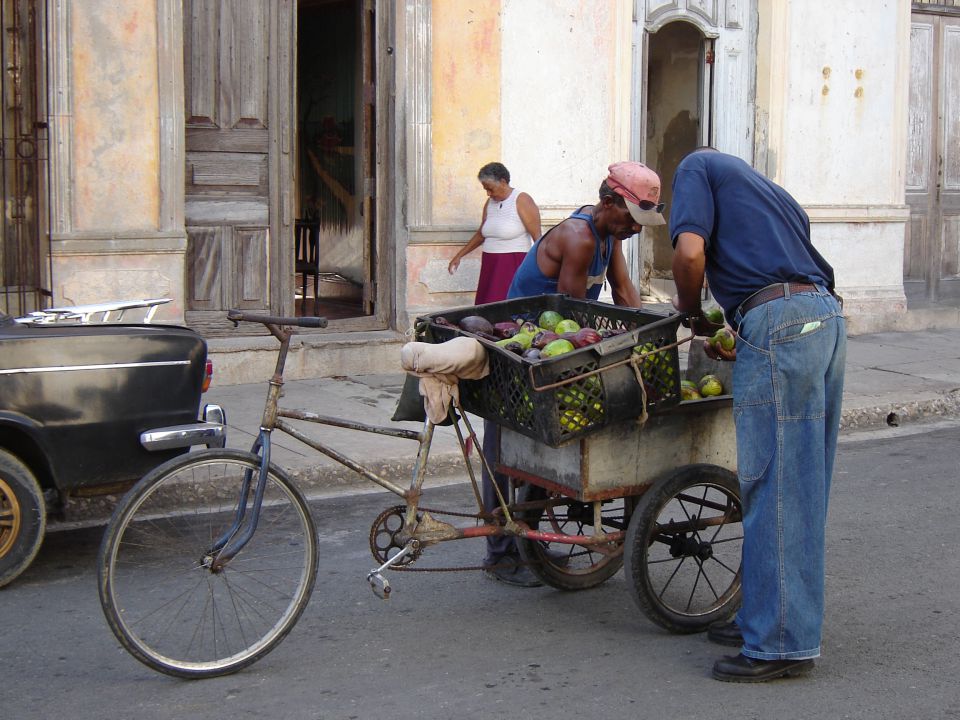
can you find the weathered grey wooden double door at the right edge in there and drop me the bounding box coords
[903,13,960,307]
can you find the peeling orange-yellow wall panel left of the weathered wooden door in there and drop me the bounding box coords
[71,0,160,231]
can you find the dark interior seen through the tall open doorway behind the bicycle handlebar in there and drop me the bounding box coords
[295,0,368,319]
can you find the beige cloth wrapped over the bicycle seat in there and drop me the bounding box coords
[400,337,490,423]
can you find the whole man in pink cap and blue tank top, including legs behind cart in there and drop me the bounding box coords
[482,162,665,587]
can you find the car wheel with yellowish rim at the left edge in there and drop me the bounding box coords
[0,450,47,587]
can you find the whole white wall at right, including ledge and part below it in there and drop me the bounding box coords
[757,0,910,330]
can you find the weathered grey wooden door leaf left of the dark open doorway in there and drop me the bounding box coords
[184,0,278,335]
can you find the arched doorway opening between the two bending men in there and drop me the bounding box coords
[644,21,712,284]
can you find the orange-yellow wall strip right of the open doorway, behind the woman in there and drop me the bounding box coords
[431,0,501,225]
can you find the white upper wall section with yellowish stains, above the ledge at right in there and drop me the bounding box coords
[774,0,909,205]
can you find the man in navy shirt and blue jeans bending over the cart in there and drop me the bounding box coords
[670,148,846,682]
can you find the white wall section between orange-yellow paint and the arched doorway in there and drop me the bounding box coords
[501,0,631,219]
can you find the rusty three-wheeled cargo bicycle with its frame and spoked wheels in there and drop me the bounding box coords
[98,310,742,679]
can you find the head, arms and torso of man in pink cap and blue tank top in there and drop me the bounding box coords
[507,161,666,307]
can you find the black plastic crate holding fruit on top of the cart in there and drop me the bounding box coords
[416,295,680,447]
